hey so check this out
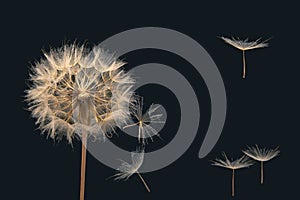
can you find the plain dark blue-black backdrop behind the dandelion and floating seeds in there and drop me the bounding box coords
[1,1,299,200]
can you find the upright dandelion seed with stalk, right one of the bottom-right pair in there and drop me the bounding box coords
[243,145,280,184]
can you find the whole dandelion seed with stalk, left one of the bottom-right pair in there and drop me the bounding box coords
[212,153,253,196]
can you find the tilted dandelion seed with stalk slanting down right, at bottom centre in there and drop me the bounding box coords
[114,149,150,192]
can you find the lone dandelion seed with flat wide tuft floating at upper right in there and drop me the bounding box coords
[221,37,270,78]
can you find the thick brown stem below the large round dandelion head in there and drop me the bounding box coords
[80,134,87,200]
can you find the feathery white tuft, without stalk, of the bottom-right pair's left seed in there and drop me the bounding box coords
[212,153,253,170]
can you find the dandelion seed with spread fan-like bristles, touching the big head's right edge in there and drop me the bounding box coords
[123,97,165,144]
